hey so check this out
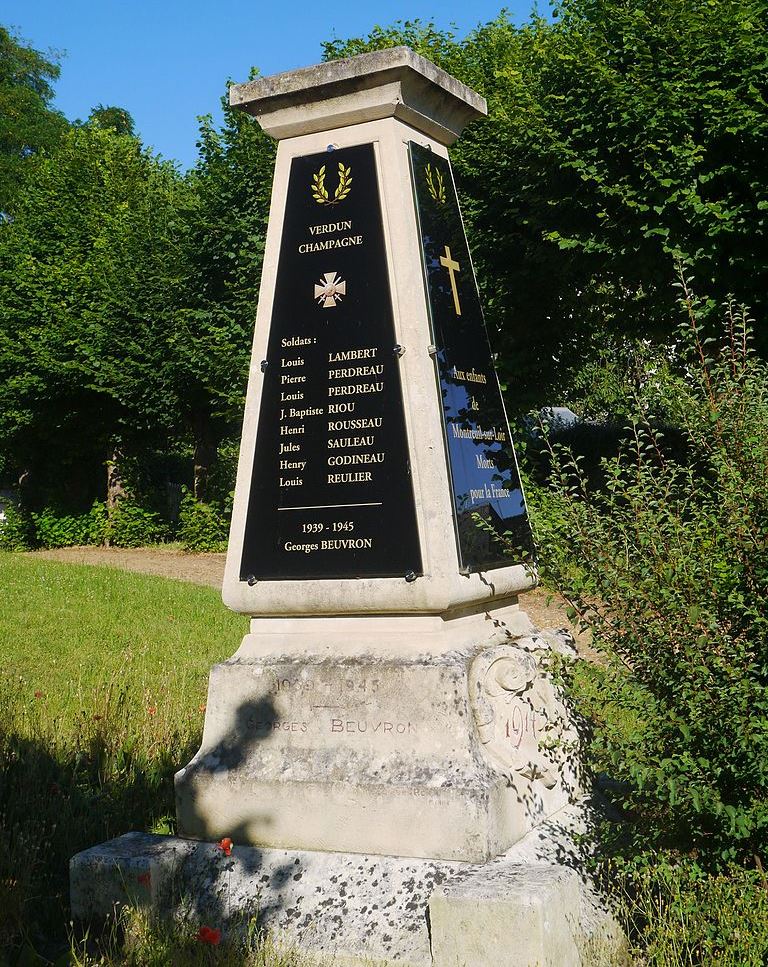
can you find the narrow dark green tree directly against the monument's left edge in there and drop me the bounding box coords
[172,82,275,498]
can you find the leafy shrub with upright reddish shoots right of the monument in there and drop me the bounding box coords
[532,285,768,867]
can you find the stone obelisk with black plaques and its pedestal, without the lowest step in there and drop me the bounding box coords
[177,47,575,862]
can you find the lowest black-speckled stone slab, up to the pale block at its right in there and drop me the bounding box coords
[70,833,460,967]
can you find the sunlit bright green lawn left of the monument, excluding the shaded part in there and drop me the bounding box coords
[0,553,246,715]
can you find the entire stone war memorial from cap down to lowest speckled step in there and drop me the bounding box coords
[71,47,622,967]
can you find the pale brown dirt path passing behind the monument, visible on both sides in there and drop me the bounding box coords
[25,547,588,650]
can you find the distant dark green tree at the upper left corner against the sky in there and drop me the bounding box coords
[0,26,67,216]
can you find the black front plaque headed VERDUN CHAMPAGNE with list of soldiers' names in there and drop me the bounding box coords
[240,144,422,580]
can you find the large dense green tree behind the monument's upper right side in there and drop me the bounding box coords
[325,0,768,408]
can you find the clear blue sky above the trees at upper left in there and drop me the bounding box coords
[0,0,546,168]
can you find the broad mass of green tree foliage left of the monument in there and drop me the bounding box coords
[0,34,275,514]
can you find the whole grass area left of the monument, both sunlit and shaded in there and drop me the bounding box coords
[0,553,247,963]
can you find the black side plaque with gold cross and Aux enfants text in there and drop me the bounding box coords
[409,142,532,571]
